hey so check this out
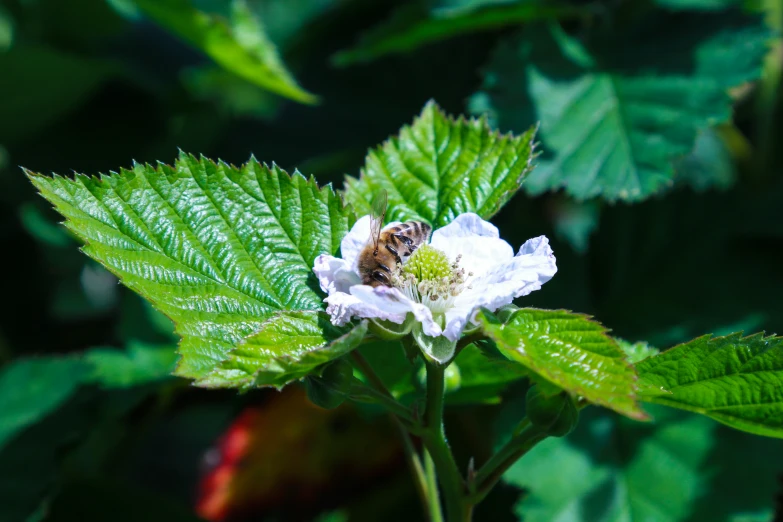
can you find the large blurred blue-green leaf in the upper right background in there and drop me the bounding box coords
[471,13,771,201]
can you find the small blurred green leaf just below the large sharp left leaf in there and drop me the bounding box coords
[84,342,177,388]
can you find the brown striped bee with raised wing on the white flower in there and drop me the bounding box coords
[358,191,432,287]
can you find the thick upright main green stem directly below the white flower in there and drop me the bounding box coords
[421,362,465,522]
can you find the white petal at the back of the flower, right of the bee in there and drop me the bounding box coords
[430,213,514,277]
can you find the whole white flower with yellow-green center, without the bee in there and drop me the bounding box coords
[313,213,557,362]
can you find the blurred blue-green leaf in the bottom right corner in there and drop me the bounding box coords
[503,408,783,522]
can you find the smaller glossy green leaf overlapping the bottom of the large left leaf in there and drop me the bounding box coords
[207,311,367,387]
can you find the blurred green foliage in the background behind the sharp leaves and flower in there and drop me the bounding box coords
[0,0,783,522]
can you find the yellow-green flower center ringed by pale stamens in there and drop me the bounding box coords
[392,245,473,314]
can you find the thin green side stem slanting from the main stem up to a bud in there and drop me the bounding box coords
[469,418,547,505]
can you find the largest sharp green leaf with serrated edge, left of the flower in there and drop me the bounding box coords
[28,154,353,386]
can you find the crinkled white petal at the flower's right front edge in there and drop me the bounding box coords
[444,236,557,340]
